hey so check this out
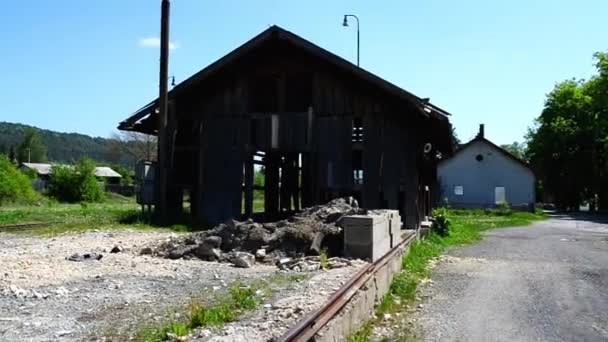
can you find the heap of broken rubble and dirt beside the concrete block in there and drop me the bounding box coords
[148,197,366,270]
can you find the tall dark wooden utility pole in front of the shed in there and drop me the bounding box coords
[156,0,171,224]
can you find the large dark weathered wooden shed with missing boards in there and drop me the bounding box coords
[118,26,451,228]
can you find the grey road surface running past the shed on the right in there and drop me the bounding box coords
[413,216,608,341]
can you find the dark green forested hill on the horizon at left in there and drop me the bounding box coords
[0,122,110,162]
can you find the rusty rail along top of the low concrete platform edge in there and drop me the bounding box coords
[277,234,416,342]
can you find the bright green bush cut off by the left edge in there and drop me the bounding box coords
[0,155,39,205]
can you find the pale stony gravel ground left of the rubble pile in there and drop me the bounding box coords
[0,231,276,341]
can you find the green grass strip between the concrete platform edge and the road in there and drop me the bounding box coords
[348,208,545,342]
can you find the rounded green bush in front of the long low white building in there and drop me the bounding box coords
[49,159,104,202]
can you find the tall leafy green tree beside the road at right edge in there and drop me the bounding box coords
[526,53,608,210]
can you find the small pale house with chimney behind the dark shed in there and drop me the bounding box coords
[437,125,535,208]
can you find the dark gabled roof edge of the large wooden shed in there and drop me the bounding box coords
[118,25,450,130]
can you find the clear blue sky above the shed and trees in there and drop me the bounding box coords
[0,0,608,144]
